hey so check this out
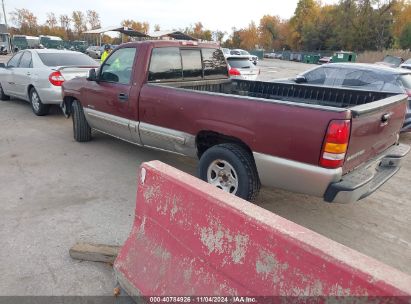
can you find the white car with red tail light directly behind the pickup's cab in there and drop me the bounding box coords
[226,56,260,80]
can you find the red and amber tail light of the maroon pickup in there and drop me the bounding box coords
[320,120,351,169]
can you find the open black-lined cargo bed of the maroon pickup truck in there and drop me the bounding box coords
[162,79,395,108]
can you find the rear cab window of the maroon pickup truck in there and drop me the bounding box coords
[148,47,228,82]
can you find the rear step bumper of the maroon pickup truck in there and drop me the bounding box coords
[324,144,410,203]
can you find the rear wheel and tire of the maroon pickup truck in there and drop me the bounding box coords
[198,144,261,201]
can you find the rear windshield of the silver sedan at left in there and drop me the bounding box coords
[39,53,97,67]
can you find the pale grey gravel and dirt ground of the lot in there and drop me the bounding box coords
[0,56,411,296]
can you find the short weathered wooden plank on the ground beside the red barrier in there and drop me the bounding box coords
[69,243,120,264]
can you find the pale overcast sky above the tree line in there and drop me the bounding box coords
[1,0,337,33]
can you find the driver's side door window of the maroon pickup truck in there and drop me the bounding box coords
[100,48,137,84]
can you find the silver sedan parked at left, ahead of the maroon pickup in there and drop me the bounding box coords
[0,49,98,116]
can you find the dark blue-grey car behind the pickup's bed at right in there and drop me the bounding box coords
[282,63,411,131]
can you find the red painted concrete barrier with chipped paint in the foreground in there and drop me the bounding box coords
[114,161,411,302]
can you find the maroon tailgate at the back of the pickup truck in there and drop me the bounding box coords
[343,94,407,173]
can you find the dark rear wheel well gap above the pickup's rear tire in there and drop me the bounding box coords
[196,131,253,158]
